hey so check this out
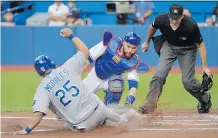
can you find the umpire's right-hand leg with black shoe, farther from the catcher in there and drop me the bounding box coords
[178,49,212,113]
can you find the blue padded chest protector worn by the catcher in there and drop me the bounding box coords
[95,37,139,79]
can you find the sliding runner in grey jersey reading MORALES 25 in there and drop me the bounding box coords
[14,28,127,134]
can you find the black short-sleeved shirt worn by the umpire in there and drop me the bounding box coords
[152,13,203,46]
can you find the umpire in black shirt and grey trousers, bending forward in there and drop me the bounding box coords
[140,4,212,113]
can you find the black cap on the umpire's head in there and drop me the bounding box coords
[169,4,183,19]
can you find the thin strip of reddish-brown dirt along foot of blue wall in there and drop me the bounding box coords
[1,66,218,74]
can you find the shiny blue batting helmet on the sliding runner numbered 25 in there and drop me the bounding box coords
[34,55,56,76]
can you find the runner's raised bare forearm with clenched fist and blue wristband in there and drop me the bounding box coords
[60,28,89,59]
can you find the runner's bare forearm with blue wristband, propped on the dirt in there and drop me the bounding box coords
[13,112,43,135]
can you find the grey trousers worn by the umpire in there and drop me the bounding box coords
[146,41,207,110]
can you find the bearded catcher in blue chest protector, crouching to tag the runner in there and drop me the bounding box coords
[83,31,148,104]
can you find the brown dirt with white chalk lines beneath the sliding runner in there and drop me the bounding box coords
[1,110,218,138]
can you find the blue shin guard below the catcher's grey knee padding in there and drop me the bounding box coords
[104,90,122,105]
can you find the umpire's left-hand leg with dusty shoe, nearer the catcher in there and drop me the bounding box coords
[139,42,176,114]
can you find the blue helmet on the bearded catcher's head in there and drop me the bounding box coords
[124,32,141,46]
